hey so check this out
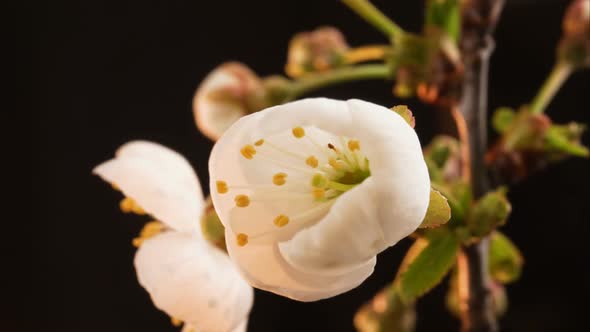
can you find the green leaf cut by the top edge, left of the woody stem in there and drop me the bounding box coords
[425,0,461,43]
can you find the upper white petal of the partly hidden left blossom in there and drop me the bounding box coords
[93,141,205,232]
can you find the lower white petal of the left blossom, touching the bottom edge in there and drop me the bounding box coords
[135,231,253,332]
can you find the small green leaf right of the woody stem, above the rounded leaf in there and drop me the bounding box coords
[467,188,512,236]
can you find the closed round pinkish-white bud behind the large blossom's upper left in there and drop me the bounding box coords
[193,62,264,141]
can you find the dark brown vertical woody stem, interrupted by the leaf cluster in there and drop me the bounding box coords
[458,0,504,332]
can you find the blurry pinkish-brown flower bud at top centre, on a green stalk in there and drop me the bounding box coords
[285,27,349,77]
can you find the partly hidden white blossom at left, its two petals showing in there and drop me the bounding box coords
[94,141,253,332]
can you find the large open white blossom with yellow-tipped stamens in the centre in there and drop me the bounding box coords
[209,98,430,301]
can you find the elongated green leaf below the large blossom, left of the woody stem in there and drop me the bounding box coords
[399,231,459,303]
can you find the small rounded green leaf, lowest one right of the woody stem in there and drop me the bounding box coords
[489,231,524,284]
